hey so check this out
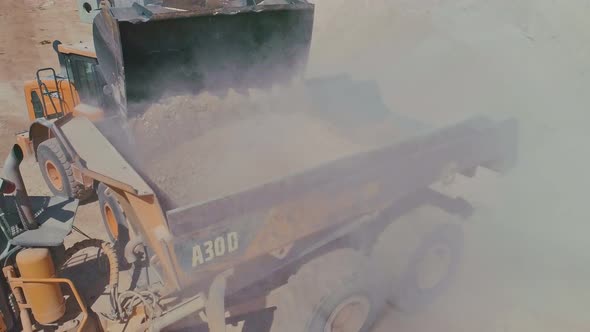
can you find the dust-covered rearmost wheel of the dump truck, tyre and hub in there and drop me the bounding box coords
[370,207,463,312]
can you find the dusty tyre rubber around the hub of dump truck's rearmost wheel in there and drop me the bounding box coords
[371,206,463,313]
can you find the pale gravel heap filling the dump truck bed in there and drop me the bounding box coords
[130,87,400,209]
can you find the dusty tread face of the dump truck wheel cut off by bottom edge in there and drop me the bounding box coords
[266,249,382,332]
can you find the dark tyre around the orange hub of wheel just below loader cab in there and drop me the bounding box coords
[37,138,94,201]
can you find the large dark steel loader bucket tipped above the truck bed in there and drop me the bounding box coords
[93,0,314,115]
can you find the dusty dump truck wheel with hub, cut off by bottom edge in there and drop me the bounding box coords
[267,249,383,332]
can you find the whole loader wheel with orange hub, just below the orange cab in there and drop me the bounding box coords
[37,138,93,201]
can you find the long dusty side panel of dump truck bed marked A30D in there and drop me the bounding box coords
[166,113,518,273]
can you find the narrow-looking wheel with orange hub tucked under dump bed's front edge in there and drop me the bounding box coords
[97,183,129,254]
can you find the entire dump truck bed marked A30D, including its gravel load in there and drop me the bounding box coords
[53,82,518,283]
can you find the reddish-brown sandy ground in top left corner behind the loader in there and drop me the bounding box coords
[0,0,91,160]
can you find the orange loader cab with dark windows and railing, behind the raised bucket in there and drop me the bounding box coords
[24,41,102,121]
